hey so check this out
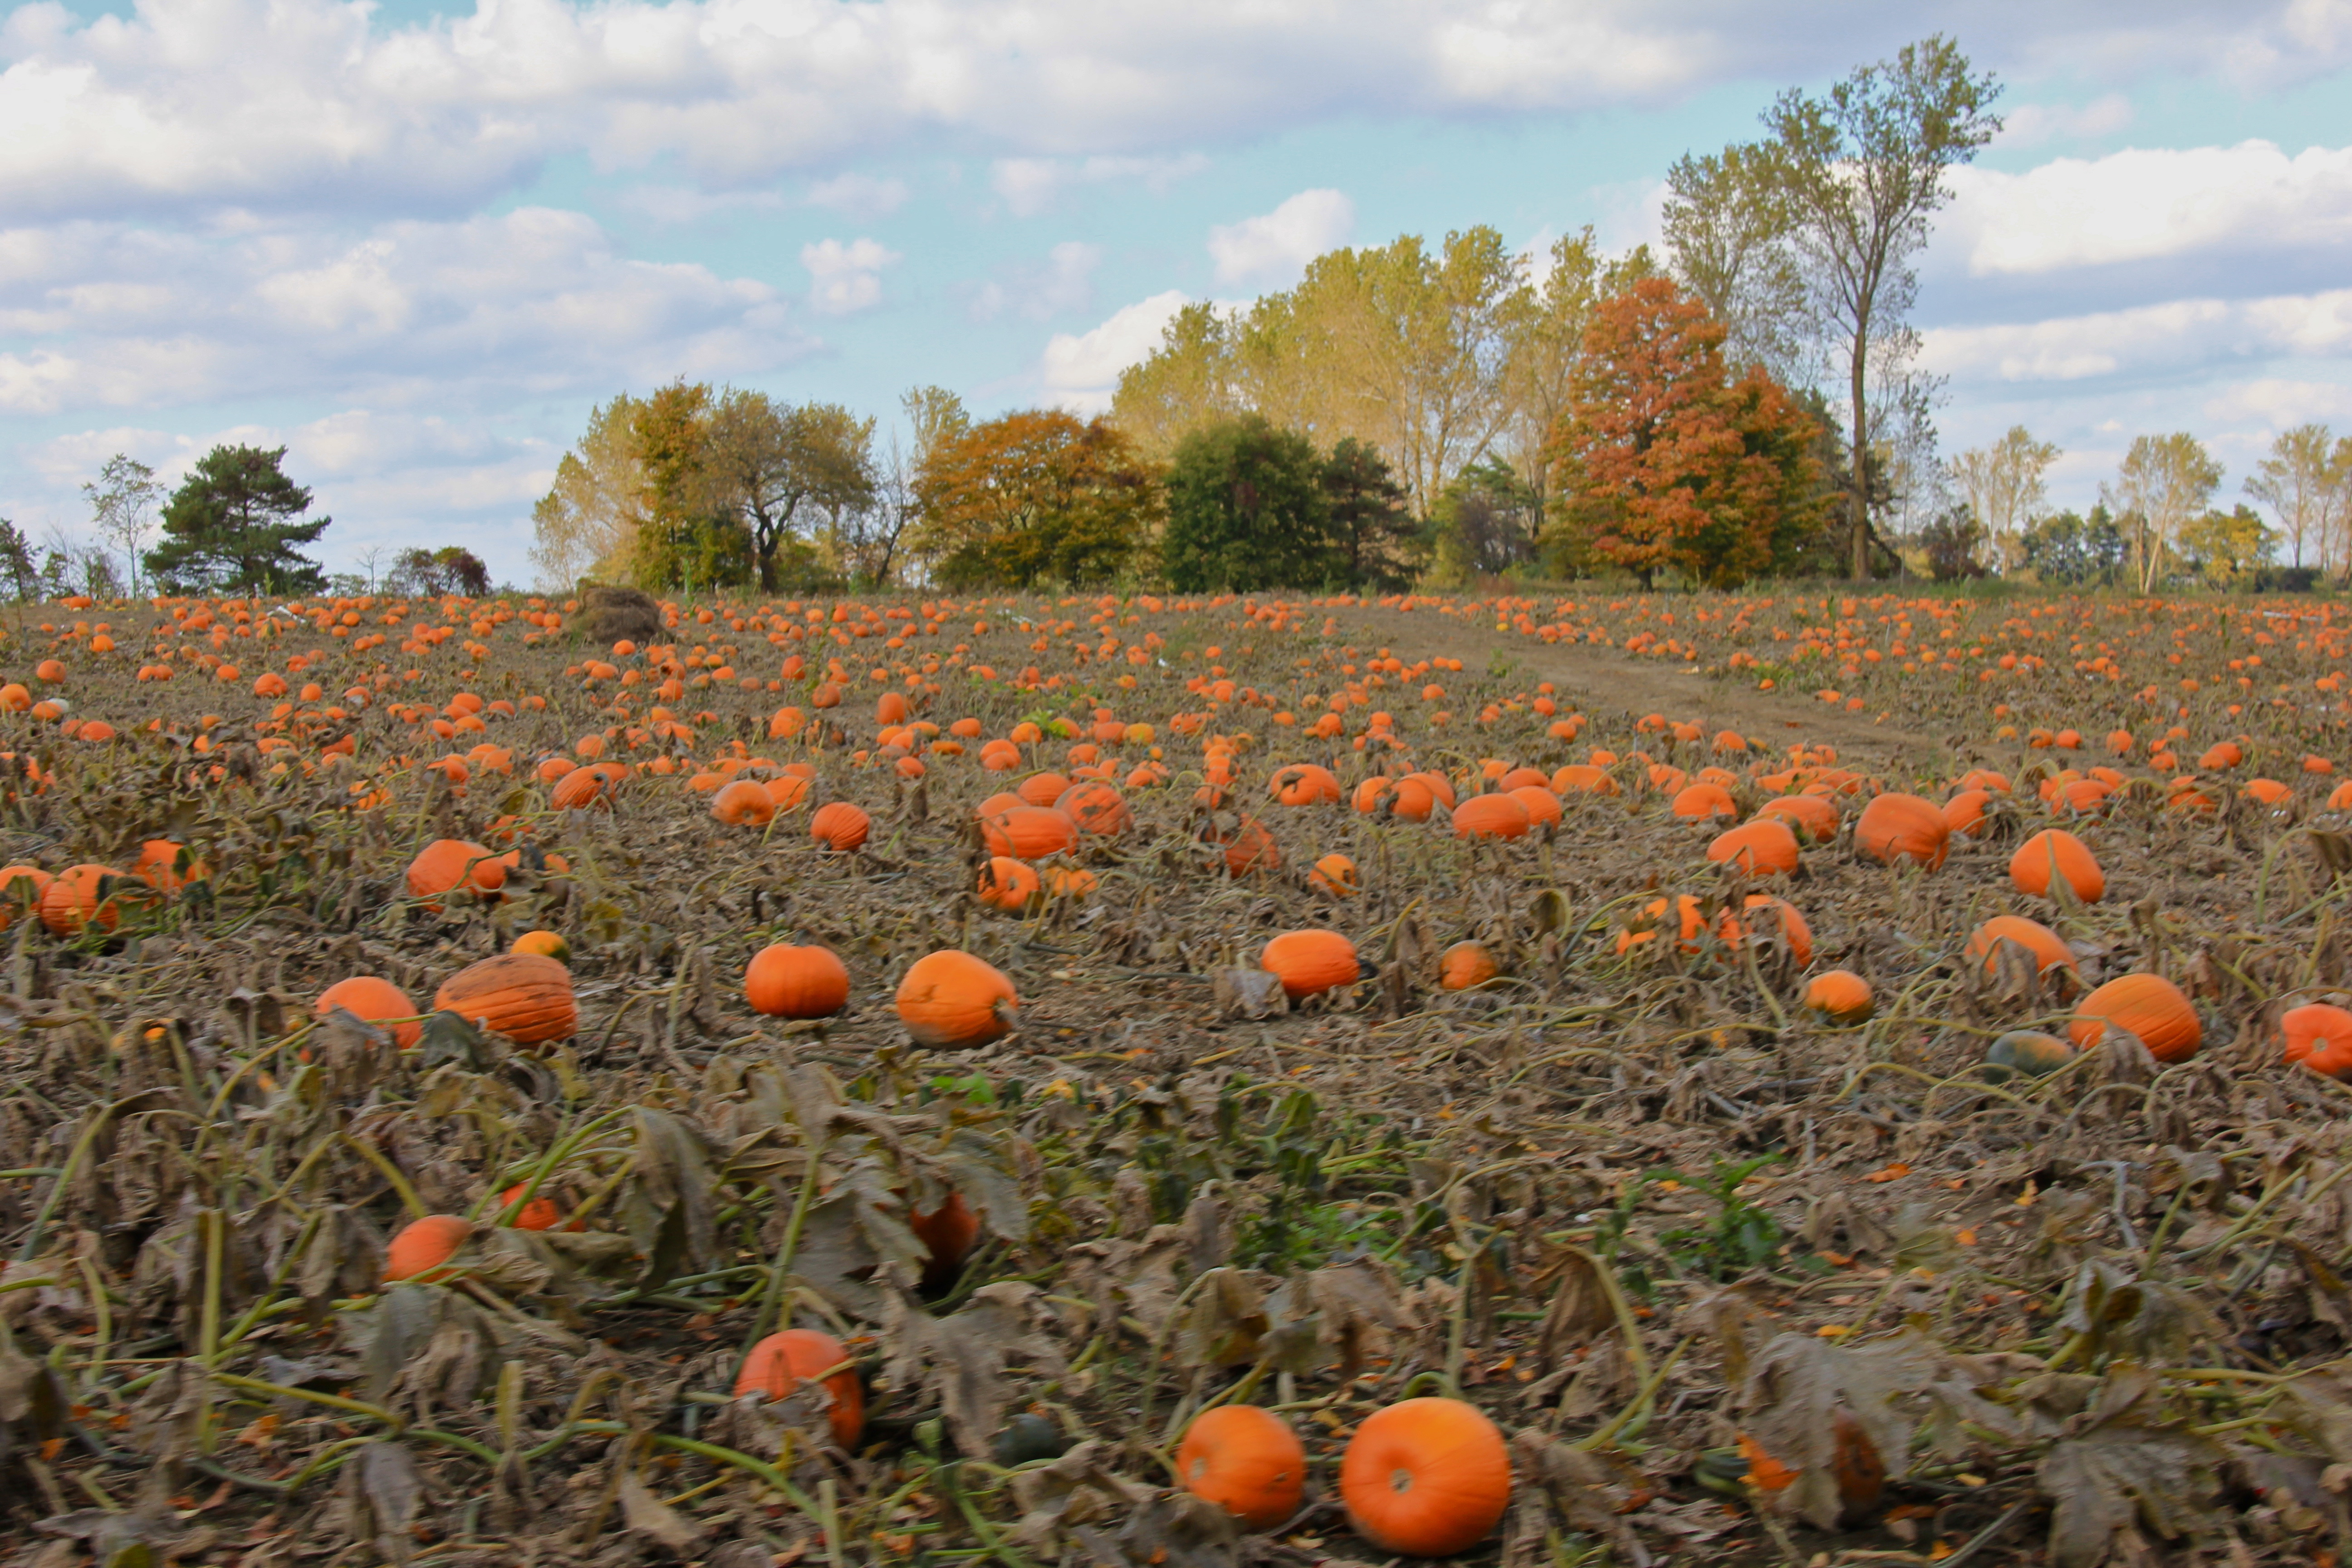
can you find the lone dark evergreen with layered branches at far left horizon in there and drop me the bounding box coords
[146,446,332,593]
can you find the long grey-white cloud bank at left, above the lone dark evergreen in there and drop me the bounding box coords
[0,207,811,416]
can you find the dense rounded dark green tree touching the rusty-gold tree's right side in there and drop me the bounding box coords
[1160,414,1348,593]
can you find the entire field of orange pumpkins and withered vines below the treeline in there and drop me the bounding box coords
[0,585,2352,1568]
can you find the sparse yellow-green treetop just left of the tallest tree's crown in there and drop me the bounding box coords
[1665,146,1808,381]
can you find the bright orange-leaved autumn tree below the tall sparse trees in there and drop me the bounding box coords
[1552,277,1823,588]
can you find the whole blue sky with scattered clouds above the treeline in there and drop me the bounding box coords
[0,0,2352,583]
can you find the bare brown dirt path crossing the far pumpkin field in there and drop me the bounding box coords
[1336,609,1952,776]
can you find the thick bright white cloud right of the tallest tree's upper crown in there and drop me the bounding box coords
[1938,141,2352,277]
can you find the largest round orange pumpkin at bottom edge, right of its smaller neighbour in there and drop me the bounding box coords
[1338,1399,1510,1556]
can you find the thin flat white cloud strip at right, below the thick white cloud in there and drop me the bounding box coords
[1921,289,2352,381]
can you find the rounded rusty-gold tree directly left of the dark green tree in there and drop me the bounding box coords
[908,409,1160,588]
